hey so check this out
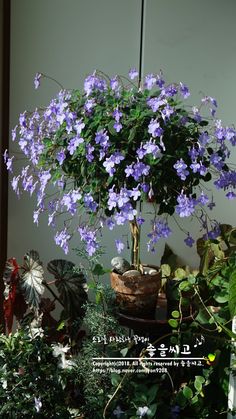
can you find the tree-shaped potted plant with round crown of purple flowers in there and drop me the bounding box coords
[4,69,236,316]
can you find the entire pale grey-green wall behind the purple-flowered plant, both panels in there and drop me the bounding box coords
[8,0,236,278]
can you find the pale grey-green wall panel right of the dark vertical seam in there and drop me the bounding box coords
[139,0,236,266]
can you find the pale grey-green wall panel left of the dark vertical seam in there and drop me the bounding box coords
[8,0,141,272]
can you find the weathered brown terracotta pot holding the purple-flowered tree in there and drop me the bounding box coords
[111,272,161,317]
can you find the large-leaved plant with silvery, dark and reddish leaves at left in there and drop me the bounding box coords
[3,250,87,333]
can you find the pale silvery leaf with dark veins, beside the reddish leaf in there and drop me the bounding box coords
[20,250,44,309]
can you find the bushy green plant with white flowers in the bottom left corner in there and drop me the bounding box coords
[0,330,77,419]
